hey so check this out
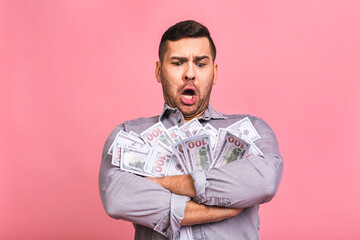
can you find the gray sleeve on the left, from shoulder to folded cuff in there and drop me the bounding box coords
[99,125,190,238]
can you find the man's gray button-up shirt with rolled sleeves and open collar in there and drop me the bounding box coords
[99,104,283,240]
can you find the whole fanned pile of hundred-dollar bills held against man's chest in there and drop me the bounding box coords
[108,117,262,177]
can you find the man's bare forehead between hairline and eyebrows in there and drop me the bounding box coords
[165,37,212,59]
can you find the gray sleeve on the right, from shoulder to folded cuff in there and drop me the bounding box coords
[190,118,283,208]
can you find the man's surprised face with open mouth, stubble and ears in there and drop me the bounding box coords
[155,37,217,120]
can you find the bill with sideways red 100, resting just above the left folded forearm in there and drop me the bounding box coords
[144,142,172,177]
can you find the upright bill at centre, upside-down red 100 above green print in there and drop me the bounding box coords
[183,135,212,171]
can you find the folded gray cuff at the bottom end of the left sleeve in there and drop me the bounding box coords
[154,193,190,239]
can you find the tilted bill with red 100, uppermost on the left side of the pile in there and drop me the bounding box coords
[140,122,173,149]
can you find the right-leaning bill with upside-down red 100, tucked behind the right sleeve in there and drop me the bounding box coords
[212,132,250,167]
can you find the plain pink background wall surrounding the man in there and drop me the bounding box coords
[0,0,360,239]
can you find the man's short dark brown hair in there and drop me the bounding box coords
[159,20,216,61]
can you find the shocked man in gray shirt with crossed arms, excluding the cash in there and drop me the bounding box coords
[99,21,283,240]
